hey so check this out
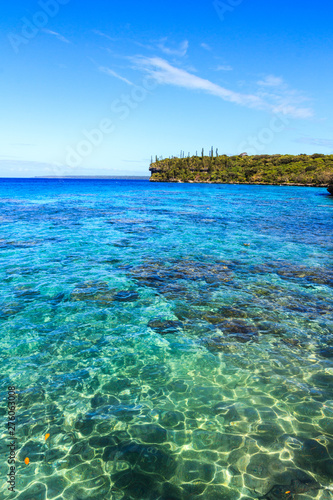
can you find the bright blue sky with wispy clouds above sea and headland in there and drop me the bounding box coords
[0,0,333,177]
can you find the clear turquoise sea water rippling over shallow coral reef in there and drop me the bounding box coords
[0,180,333,500]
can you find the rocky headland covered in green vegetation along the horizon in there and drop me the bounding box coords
[149,154,333,186]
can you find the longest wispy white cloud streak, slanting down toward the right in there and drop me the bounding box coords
[132,56,312,118]
